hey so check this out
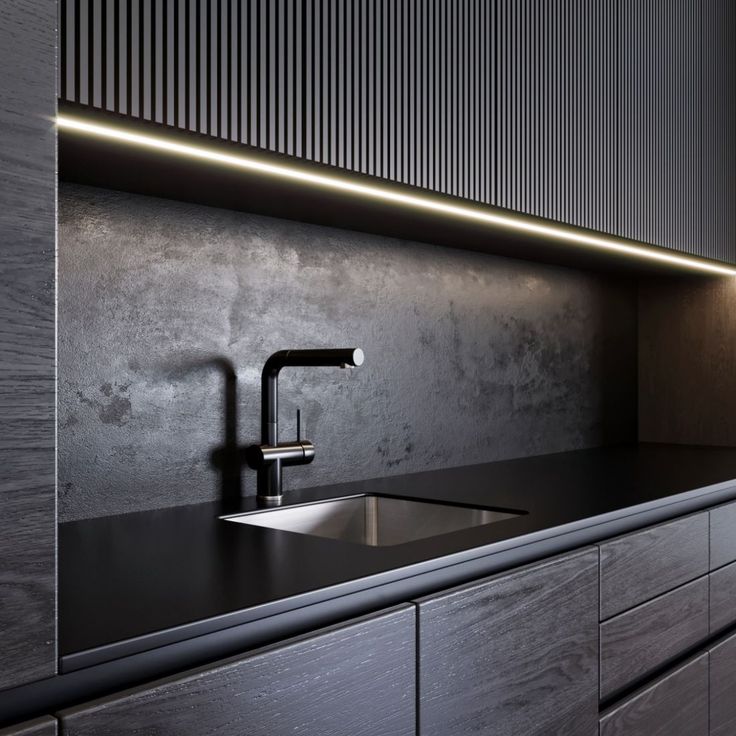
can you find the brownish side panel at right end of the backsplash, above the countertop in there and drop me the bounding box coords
[639,278,736,446]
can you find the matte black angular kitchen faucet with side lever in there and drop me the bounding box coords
[246,348,364,505]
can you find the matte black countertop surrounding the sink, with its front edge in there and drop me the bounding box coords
[59,445,736,671]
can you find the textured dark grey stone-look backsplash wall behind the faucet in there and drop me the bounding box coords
[59,184,636,520]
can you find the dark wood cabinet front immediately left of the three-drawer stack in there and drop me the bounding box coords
[418,549,598,736]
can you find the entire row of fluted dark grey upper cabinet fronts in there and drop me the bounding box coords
[60,0,736,261]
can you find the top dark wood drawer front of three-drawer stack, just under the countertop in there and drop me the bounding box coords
[600,512,709,621]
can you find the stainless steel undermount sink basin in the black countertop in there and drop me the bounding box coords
[222,495,521,547]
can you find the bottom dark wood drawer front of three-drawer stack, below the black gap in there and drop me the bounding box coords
[600,654,708,736]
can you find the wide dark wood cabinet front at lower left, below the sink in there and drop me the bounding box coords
[59,605,416,736]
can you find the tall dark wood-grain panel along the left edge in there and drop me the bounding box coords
[0,0,56,689]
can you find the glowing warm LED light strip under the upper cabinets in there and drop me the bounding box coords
[56,115,736,276]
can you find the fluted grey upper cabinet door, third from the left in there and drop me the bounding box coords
[498,0,618,233]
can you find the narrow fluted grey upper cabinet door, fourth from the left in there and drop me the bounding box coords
[617,0,701,253]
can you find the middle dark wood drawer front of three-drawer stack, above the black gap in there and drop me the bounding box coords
[600,576,708,700]
